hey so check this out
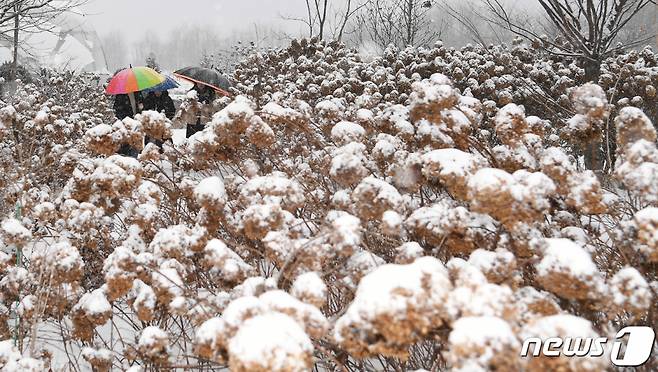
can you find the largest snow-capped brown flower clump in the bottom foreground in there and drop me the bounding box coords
[334,257,451,357]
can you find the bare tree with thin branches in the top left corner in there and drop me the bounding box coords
[0,0,86,78]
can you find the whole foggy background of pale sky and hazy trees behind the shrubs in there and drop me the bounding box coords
[0,0,655,72]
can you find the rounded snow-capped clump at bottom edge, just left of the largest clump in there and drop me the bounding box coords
[196,291,328,371]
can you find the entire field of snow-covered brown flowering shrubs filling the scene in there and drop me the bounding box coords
[0,39,658,371]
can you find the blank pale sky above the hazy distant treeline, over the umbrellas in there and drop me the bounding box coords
[84,0,305,40]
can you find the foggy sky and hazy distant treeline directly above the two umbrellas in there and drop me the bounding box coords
[83,0,320,70]
